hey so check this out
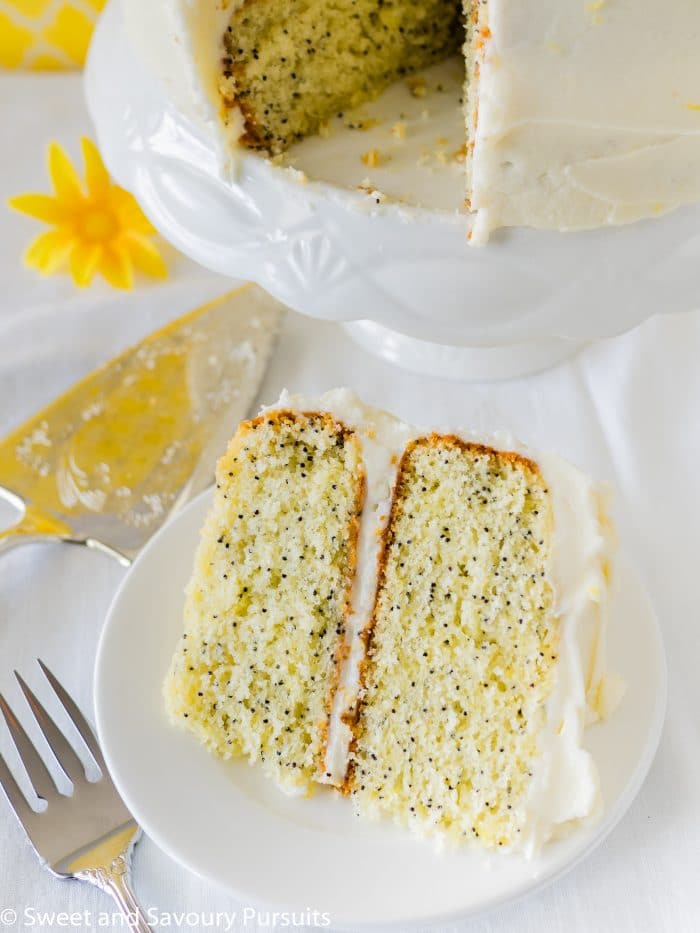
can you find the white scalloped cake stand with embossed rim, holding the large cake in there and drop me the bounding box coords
[85,0,700,379]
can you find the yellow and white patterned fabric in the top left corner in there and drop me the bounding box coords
[0,0,106,71]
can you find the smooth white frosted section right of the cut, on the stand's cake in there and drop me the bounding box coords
[471,0,700,242]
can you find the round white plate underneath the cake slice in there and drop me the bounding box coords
[95,492,666,930]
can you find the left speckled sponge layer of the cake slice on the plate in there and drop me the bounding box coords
[164,411,364,789]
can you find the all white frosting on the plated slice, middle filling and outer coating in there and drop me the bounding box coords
[265,389,619,854]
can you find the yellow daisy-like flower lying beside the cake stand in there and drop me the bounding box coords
[8,139,168,288]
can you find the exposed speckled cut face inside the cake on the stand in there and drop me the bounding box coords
[221,0,463,153]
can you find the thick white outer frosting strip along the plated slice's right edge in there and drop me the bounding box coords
[522,451,615,853]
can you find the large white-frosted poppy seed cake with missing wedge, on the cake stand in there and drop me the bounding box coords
[124,0,700,243]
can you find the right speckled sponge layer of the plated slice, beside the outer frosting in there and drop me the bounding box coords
[350,435,559,846]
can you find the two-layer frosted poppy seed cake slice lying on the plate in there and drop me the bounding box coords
[165,390,615,851]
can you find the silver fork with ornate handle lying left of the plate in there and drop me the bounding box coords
[0,661,150,933]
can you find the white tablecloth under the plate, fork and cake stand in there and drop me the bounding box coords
[0,77,700,933]
